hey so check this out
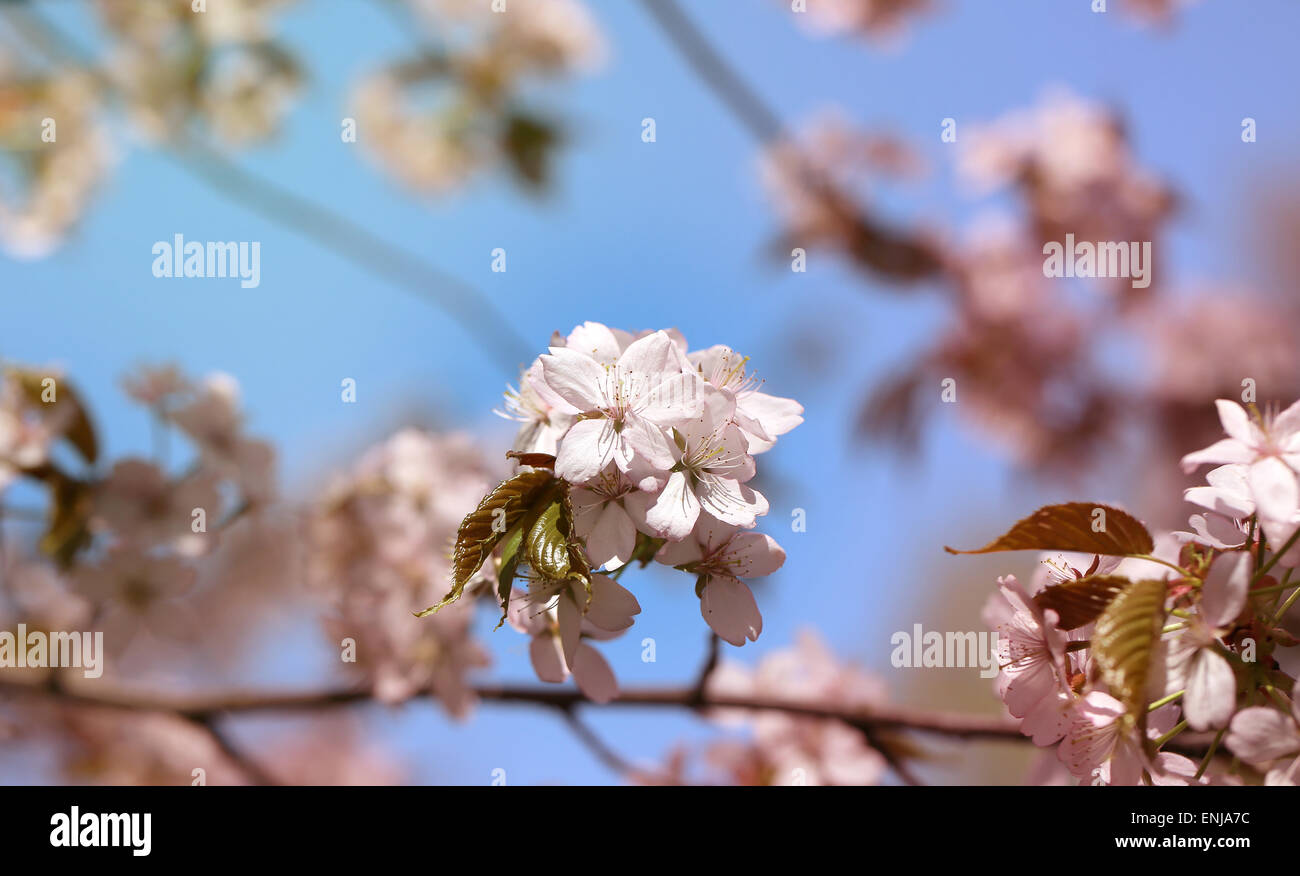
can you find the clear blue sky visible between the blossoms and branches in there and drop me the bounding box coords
[0,0,1300,784]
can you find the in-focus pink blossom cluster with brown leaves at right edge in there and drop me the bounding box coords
[987,400,1300,785]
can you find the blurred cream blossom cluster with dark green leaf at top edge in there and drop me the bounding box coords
[352,0,605,194]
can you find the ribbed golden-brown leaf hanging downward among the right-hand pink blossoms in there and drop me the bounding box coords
[1092,581,1165,727]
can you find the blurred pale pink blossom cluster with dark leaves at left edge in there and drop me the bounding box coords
[0,369,273,652]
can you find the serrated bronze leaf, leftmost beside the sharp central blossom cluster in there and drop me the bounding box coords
[416,469,563,617]
